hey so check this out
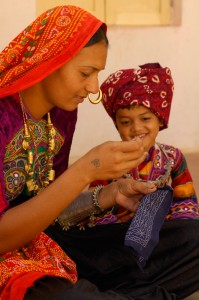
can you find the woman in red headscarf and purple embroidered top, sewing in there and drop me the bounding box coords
[0,6,156,300]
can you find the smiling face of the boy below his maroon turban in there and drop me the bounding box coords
[115,105,163,151]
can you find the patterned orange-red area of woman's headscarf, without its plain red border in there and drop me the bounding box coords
[0,6,88,87]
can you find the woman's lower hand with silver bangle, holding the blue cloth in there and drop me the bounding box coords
[98,179,157,212]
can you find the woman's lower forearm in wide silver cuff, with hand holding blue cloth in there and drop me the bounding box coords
[56,179,156,230]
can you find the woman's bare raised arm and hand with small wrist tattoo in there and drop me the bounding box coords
[0,139,145,254]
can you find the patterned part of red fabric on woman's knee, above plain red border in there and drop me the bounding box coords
[0,233,77,295]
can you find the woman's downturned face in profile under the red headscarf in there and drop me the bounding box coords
[41,41,107,111]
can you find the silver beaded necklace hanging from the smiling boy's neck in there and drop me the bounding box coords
[123,143,174,188]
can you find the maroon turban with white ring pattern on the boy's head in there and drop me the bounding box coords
[100,63,174,129]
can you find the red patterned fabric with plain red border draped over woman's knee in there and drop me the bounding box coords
[0,233,77,300]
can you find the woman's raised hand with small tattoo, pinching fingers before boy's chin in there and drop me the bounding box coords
[71,138,146,183]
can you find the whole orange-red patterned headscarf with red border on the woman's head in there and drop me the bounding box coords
[0,5,106,98]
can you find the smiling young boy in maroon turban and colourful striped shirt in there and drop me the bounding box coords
[92,63,199,224]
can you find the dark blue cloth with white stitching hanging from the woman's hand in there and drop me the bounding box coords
[124,185,173,268]
